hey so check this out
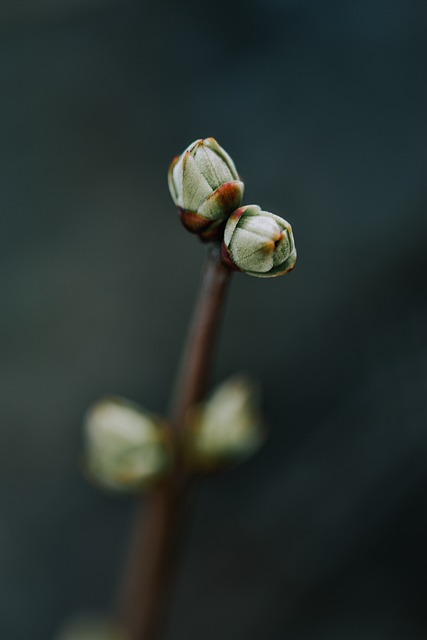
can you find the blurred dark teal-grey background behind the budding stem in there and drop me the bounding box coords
[0,0,427,640]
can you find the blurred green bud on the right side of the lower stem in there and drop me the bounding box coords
[188,376,264,470]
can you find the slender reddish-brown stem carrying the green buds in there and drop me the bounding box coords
[118,243,231,640]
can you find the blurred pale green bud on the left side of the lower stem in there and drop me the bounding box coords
[84,398,170,491]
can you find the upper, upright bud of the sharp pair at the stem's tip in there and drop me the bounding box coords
[168,138,244,240]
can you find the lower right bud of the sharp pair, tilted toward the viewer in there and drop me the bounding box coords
[221,204,297,278]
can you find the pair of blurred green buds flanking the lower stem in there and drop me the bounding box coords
[84,376,264,493]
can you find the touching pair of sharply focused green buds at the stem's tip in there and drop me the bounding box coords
[168,138,296,278]
